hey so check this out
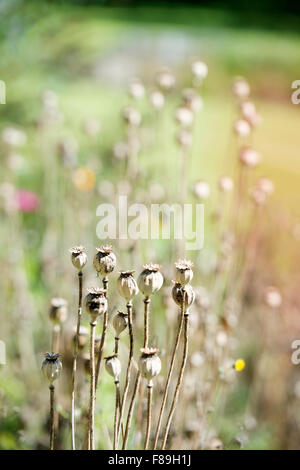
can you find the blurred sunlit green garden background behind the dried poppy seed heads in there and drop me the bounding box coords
[0,0,300,449]
